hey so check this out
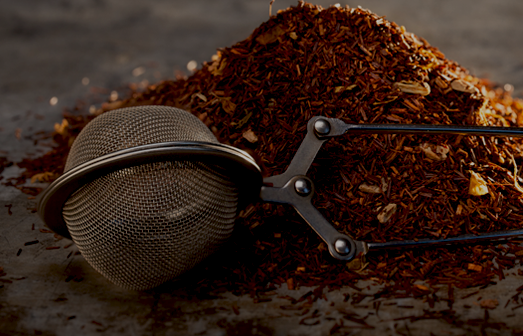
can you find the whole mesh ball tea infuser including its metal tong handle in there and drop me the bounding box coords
[38,106,523,290]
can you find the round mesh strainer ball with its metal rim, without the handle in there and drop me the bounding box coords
[38,106,261,290]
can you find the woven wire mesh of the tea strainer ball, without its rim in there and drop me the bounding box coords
[63,106,238,290]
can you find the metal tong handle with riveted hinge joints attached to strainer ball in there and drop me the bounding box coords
[260,117,523,261]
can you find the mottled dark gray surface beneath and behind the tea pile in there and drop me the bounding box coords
[0,0,523,335]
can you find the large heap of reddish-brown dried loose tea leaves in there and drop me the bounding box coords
[13,2,523,301]
